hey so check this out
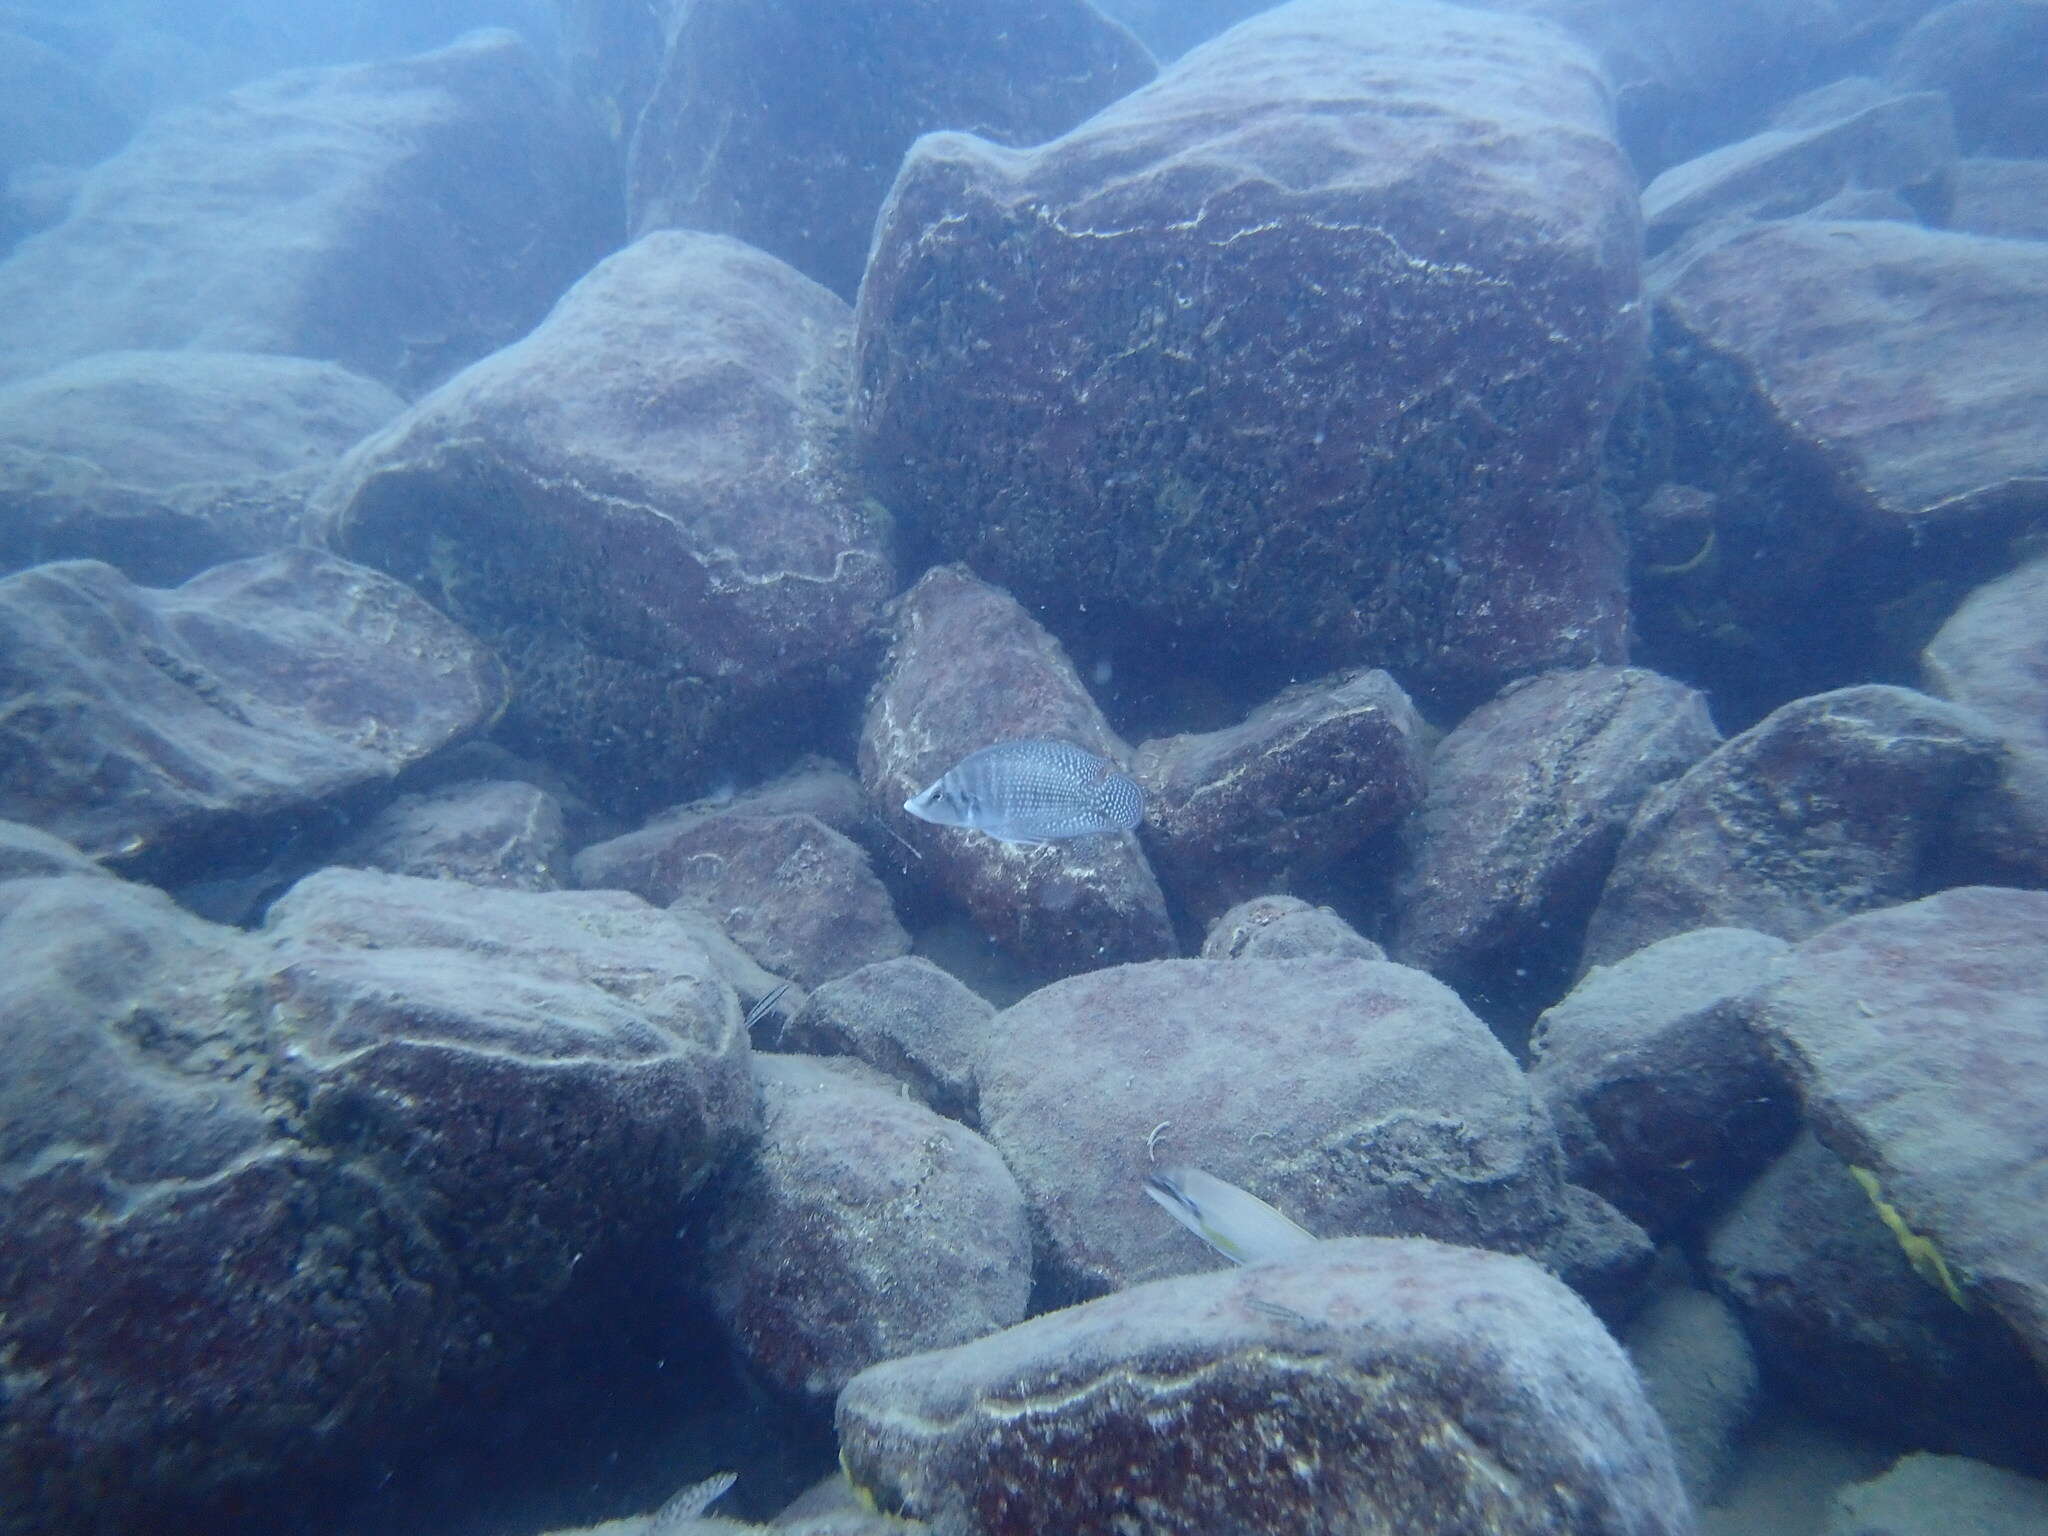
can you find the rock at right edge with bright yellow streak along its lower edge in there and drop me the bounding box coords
[1755,887,2048,1384]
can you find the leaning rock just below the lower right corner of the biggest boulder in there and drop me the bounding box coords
[1389,668,1720,1018]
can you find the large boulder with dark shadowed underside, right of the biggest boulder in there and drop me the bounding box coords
[1610,219,2048,725]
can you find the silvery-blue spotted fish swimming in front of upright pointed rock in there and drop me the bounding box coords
[903,737,1145,844]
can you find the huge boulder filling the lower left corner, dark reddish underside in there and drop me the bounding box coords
[0,870,756,1536]
